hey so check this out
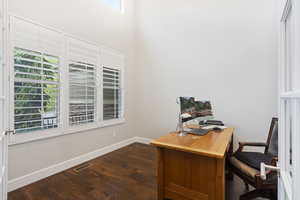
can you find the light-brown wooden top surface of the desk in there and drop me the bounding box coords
[151,128,234,158]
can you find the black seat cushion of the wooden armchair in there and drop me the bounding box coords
[234,152,273,170]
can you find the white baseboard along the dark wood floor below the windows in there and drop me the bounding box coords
[8,137,151,192]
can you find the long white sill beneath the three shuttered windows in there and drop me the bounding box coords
[9,118,126,146]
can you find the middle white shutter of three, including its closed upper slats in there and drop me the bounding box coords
[68,39,99,126]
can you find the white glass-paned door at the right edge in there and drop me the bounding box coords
[278,0,300,200]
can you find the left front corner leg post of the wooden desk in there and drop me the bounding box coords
[157,147,164,200]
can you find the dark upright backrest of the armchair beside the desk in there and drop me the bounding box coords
[265,117,278,156]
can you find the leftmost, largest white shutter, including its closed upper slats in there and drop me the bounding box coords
[11,17,63,133]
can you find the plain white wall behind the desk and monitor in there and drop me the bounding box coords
[136,0,277,147]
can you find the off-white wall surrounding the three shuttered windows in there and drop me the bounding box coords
[9,0,134,180]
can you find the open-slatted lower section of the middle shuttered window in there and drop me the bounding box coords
[69,62,96,125]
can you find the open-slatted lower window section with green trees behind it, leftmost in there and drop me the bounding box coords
[14,47,59,133]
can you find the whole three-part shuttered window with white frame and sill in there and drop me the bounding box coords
[9,16,124,144]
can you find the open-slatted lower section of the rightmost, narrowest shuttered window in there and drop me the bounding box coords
[103,67,122,120]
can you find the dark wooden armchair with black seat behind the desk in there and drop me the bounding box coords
[229,118,278,200]
